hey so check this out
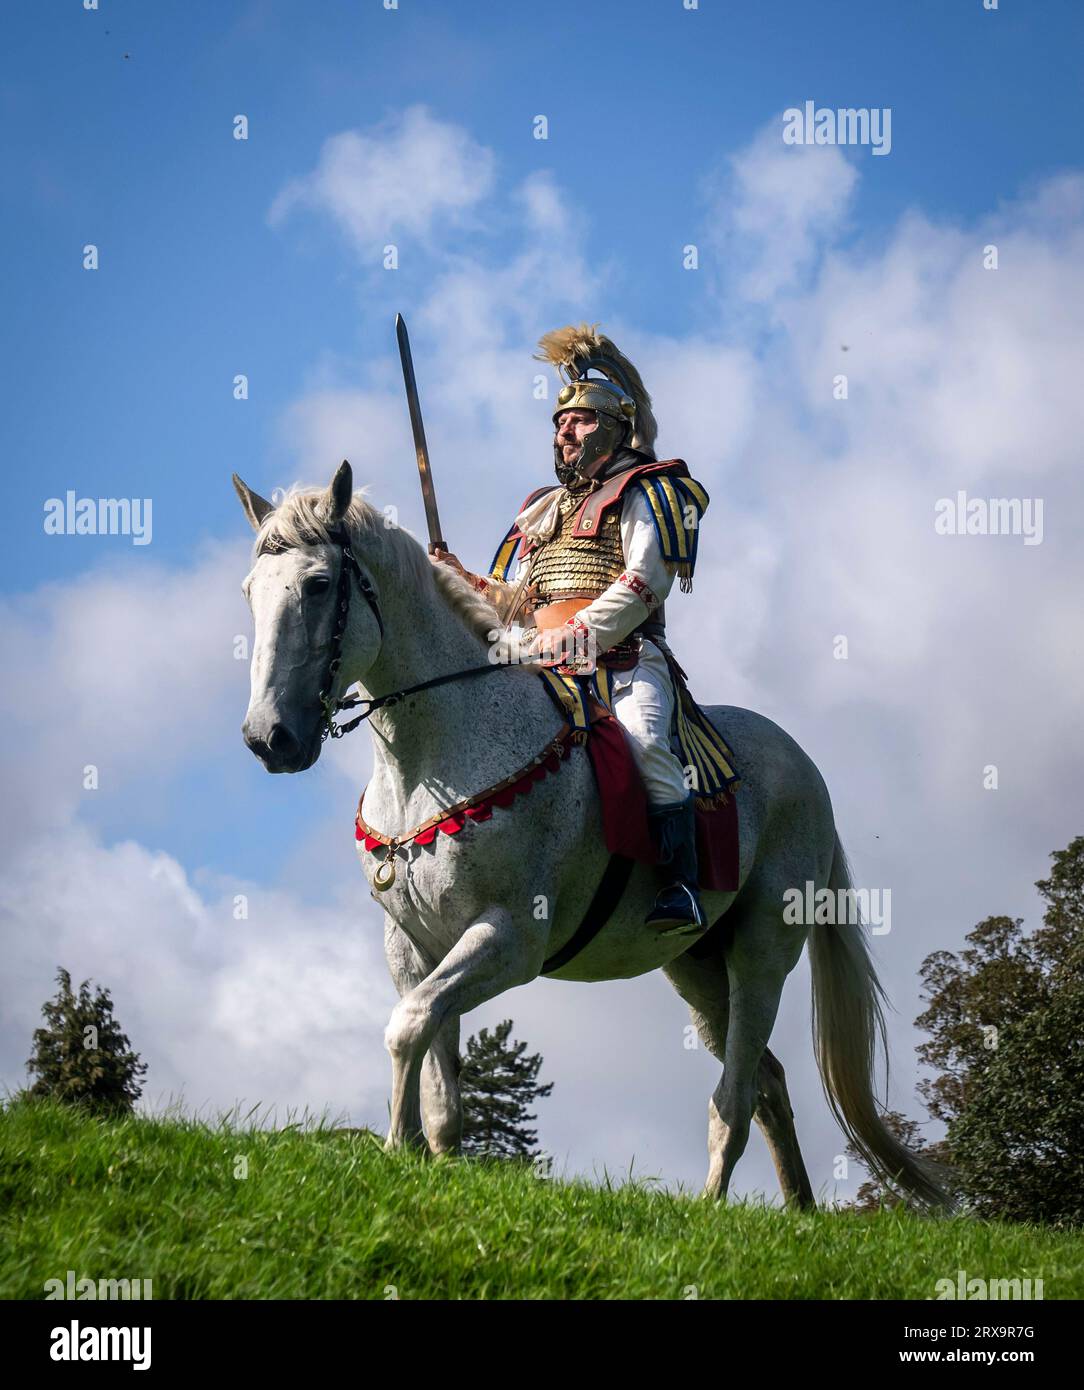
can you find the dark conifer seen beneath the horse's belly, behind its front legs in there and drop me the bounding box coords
[459,1019,553,1159]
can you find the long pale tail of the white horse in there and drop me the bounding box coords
[809,833,952,1211]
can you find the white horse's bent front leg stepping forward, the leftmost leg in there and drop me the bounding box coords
[384,906,546,1148]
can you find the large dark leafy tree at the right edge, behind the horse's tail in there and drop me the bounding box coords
[916,837,1084,1226]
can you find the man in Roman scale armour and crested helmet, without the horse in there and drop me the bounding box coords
[434,324,714,934]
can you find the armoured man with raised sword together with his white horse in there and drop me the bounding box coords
[233,330,949,1208]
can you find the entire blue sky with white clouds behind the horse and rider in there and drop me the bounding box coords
[0,0,1084,1206]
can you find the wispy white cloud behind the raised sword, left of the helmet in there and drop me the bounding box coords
[271,172,605,542]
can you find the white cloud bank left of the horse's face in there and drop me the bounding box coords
[0,539,250,845]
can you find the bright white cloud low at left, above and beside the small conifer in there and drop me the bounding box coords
[0,824,395,1123]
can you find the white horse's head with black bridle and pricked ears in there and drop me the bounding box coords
[233,463,382,773]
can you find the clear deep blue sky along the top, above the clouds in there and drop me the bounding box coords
[0,0,1084,585]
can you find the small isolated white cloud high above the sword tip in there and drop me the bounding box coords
[268,106,493,260]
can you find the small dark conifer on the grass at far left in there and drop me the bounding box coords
[26,970,147,1115]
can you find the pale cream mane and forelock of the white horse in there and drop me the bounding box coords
[253,484,500,642]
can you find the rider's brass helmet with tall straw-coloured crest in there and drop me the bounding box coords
[535,324,656,484]
